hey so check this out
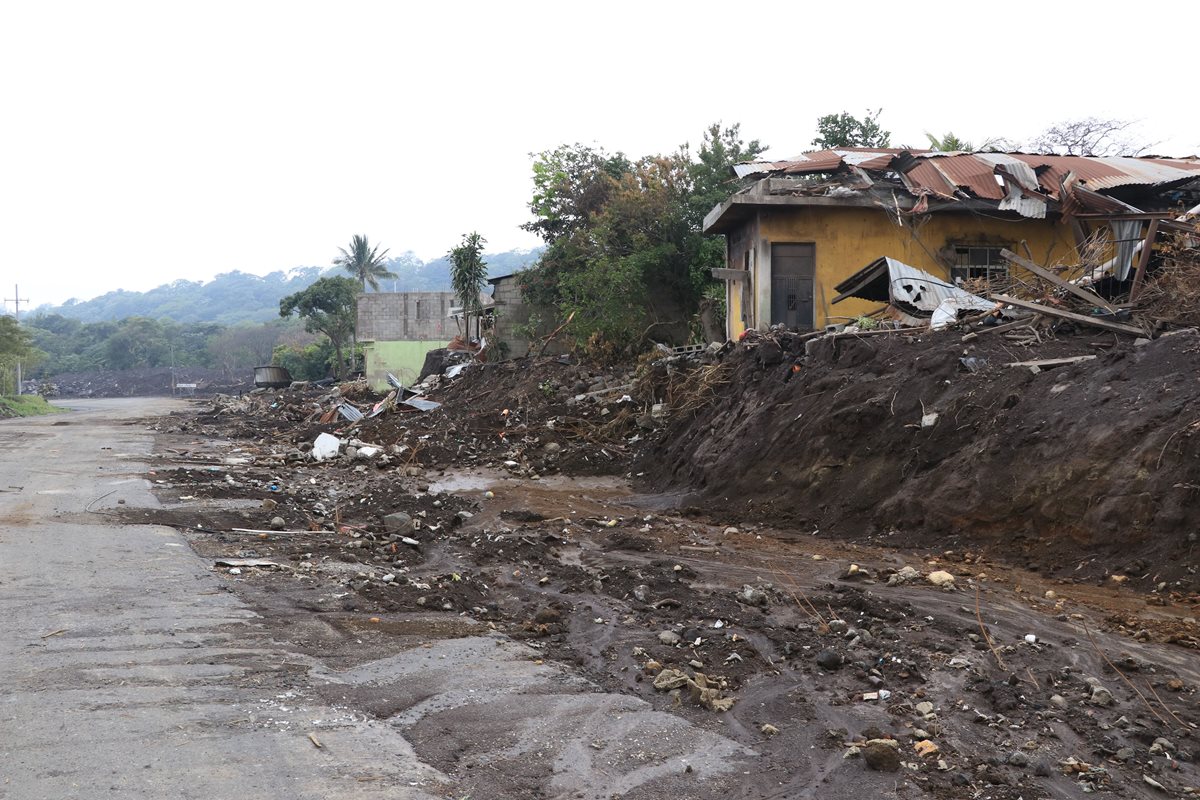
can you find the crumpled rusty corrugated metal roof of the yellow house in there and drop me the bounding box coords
[704,148,1200,233]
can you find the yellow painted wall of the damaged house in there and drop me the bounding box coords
[753,206,1073,329]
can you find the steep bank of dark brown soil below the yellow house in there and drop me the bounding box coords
[637,333,1200,594]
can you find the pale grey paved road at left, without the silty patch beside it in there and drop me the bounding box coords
[0,399,437,800]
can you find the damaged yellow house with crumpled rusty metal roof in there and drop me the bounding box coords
[704,148,1200,338]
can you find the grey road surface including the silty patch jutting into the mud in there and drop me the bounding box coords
[0,399,750,800]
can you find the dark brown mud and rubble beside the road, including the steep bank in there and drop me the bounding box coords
[114,336,1200,800]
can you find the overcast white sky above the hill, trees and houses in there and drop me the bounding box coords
[0,0,1200,311]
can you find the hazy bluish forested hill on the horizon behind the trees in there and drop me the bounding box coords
[34,248,541,325]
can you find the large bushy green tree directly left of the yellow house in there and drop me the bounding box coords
[520,125,763,354]
